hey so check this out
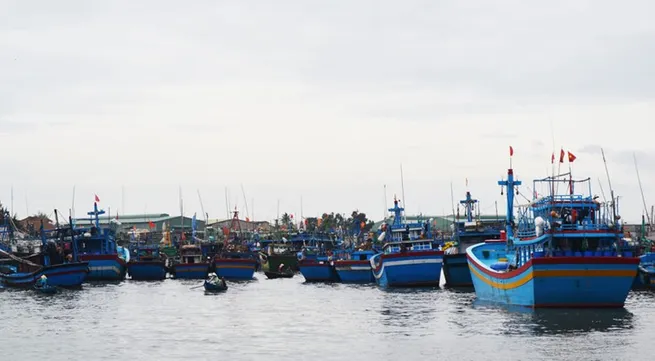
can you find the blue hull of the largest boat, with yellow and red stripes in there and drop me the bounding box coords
[467,243,639,308]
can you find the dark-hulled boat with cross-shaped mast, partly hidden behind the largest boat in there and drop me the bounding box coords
[443,191,504,287]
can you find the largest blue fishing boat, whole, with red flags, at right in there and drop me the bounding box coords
[466,159,639,308]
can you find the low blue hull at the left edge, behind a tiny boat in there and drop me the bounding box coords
[0,262,89,288]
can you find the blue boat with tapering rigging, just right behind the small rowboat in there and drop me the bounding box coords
[214,210,259,280]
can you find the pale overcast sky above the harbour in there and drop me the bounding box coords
[0,0,655,222]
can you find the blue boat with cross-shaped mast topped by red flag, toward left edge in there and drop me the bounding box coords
[73,202,127,281]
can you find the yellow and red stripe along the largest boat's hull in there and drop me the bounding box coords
[469,265,637,290]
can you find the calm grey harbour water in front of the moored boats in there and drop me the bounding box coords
[0,274,655,361]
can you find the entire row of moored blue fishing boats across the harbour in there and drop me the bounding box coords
[0,148,655,307]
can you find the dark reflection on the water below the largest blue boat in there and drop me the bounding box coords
[473,299,634,336]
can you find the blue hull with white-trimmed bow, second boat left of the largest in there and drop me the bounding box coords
[371,251,443,287]
